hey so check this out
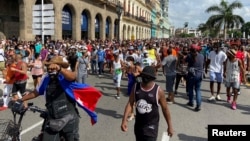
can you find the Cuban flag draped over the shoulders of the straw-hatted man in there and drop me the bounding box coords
[37,74,102,125]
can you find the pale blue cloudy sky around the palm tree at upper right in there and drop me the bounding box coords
[168,0,250,28]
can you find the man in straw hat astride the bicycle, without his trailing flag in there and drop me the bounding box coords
[17,56,79,141]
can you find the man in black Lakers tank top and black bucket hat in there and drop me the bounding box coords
[121,66,173,141]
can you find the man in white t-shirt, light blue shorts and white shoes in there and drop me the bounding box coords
[205,42,227,101]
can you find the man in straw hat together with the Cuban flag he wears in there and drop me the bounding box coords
[21,56,101,141]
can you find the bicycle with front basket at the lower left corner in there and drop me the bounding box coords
[0,103,47,141]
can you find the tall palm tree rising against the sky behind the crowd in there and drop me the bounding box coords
[206,0,244,39]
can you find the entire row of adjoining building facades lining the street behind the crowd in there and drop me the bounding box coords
[0,0,170,40]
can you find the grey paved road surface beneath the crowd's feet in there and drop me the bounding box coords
[0,72,250,141]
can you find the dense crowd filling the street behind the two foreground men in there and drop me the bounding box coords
[0,38,250,138]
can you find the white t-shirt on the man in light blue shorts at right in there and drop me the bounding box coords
[208,51,227,73]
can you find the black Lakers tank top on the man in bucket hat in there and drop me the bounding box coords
[134,83,160,137]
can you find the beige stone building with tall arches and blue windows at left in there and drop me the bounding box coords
[0,0,122,40]
